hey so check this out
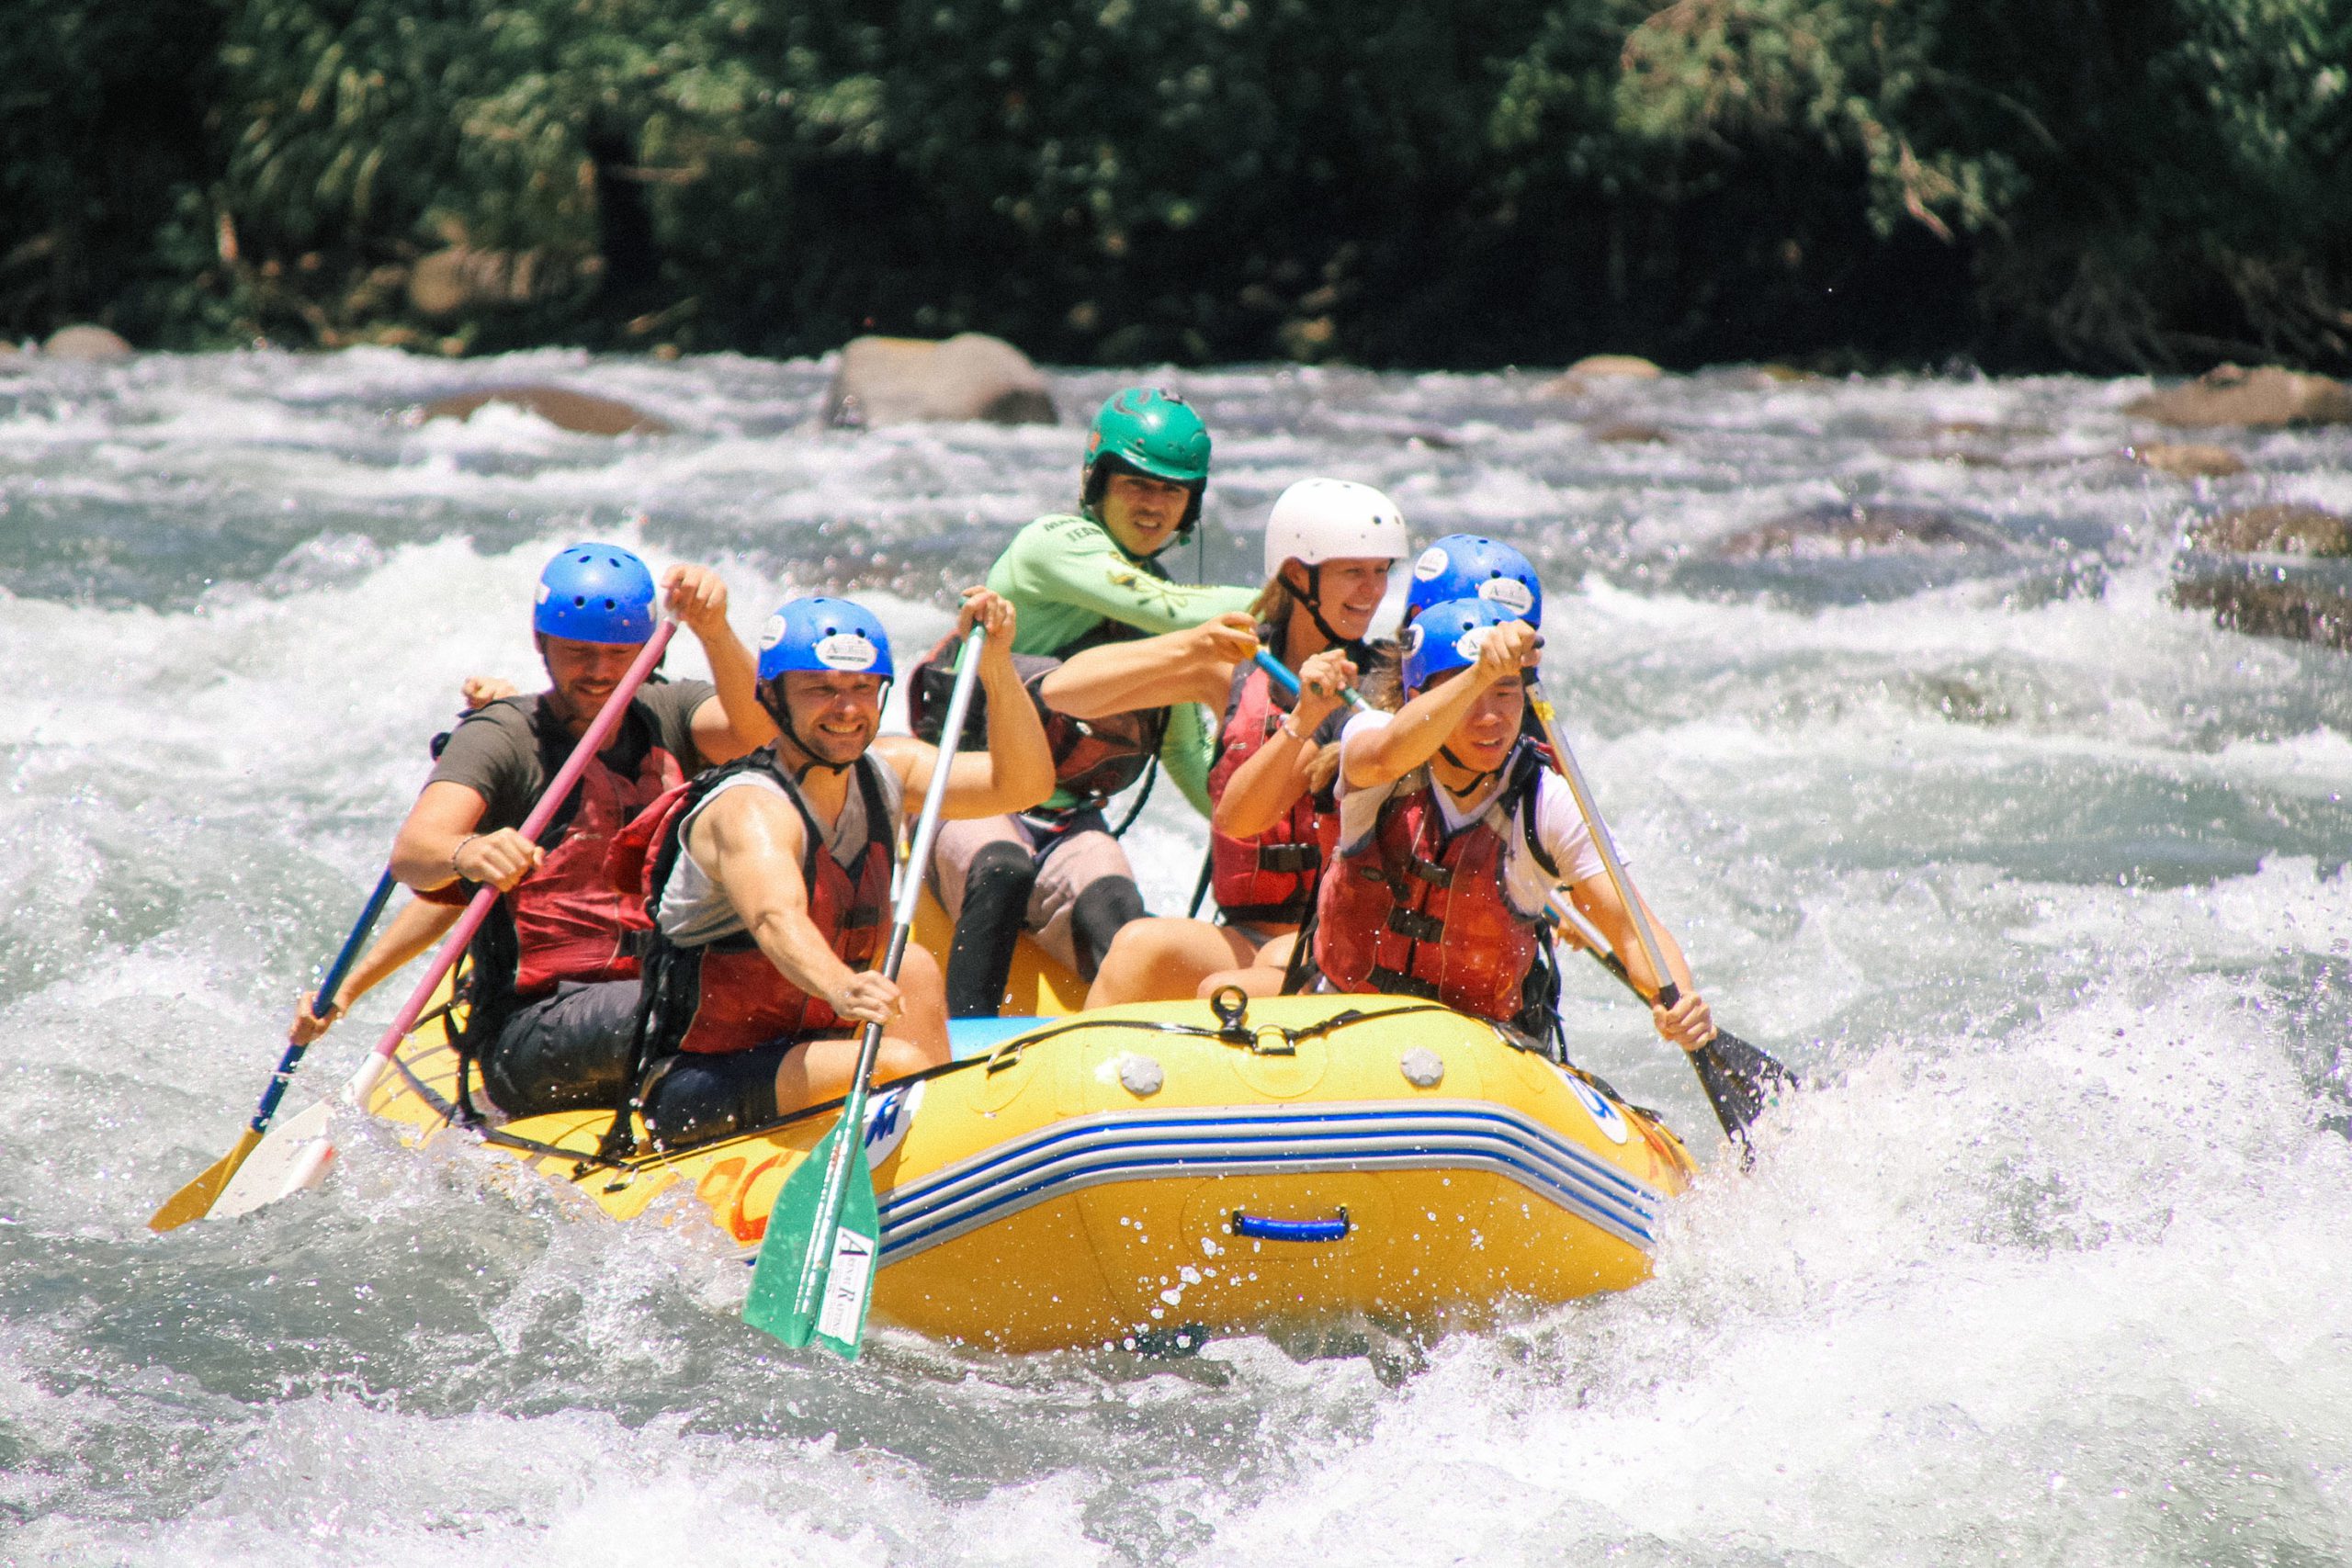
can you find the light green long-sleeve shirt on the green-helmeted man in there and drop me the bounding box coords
[988,514,1259,816]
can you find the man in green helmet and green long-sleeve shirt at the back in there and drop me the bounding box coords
[932,388,1256,1018]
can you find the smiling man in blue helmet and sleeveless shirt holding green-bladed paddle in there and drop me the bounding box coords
[606,588,1054,1147]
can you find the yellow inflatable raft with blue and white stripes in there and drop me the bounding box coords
[369,909,1693,1352]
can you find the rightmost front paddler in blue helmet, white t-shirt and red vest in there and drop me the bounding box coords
[1315,597,1714,1051]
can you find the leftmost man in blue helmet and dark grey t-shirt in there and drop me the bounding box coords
[393,543,764,1117]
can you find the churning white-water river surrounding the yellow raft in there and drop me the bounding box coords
[0,350,2352,1568]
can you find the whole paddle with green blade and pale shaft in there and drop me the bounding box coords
[743,626,988,1361]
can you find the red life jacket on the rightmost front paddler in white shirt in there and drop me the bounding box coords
[1315,745,1553,1022]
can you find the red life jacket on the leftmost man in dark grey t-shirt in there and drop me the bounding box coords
[421,701,684,1013]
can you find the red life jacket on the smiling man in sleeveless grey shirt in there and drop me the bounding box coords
[605,745,900,1060]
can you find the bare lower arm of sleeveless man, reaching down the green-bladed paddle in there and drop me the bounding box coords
[687,787,906,1022]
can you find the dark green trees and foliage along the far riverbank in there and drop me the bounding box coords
[0,0,2352,371]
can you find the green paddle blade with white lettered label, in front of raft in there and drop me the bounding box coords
[743,1126,882,1361]
